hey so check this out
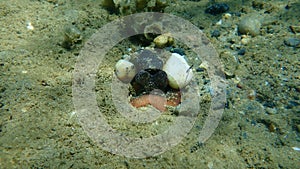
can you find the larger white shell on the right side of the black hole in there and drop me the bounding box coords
[163,53,193,89]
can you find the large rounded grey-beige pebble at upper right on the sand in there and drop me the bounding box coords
[238,16,261,36]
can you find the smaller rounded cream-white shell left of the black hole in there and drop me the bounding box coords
[115,59,136,83]
